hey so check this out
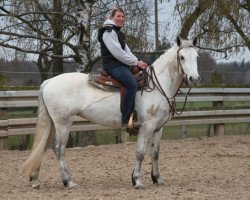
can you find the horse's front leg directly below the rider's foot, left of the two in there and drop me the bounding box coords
[132,125,152,189]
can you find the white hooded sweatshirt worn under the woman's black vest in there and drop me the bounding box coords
[102,19,138,65]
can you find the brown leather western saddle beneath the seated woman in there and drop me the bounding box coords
[89,67,147,109]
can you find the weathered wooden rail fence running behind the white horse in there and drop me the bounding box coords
[0,88,250,148]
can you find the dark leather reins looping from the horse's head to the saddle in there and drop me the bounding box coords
[144,48,191,116]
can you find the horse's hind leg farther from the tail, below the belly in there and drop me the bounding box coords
[53,119,76,188]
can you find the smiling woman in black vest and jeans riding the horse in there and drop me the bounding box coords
[98,8,148,126]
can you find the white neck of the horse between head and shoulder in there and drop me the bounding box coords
[153,46,182,97]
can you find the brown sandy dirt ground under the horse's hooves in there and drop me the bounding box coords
[0,136,250,200]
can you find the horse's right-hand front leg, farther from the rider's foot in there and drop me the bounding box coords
[150,128,165,186]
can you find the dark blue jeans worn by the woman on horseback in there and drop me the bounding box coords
[106,66,138,124]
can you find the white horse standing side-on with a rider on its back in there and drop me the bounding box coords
[21,37,200,189]
